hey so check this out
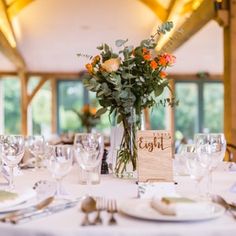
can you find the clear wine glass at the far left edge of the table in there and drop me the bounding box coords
[0,135,25,190]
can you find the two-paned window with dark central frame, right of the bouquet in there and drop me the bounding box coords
[175,79,224,144]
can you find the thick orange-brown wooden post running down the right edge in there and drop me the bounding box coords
[224,0,236,159]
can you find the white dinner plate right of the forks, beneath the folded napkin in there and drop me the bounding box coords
[119,199,225,222]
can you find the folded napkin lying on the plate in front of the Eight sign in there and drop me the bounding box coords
[151,197,213,217]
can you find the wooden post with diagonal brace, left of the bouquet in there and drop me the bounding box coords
[19,71,28,136]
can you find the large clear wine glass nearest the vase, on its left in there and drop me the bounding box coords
[74,133,104,185]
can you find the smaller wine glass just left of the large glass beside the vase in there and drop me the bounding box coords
[48,145,74,198]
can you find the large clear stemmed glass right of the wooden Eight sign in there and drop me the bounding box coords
[194,133,226,196]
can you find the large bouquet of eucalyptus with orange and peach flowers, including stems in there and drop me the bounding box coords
[79,22,177,177]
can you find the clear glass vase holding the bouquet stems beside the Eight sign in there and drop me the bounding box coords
[113,108,143,178]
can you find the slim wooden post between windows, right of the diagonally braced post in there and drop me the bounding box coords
[51,78,57,134]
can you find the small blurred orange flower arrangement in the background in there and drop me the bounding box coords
[73,104,100,133]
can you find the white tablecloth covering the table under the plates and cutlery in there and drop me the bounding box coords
[0,164,236,236]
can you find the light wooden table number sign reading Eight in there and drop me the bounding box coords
[137,130,173,182]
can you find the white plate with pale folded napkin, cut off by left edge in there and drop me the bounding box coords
[0,189,36,211]
